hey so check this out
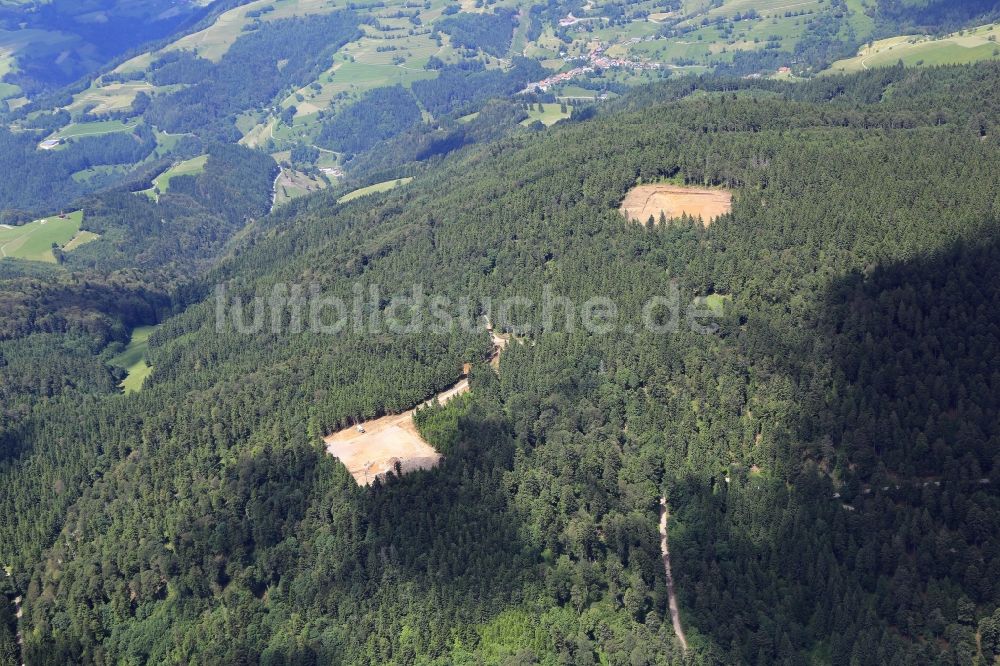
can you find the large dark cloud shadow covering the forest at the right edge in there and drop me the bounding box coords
[667,240,1000,666]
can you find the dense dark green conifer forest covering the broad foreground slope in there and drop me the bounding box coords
[0,61,1000,666]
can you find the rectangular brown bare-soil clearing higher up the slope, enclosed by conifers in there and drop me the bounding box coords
[619,183,733,225]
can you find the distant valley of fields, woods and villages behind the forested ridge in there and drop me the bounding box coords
[0,0,1000,221]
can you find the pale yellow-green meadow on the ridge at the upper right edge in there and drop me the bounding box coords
[827,24,1000,72]
